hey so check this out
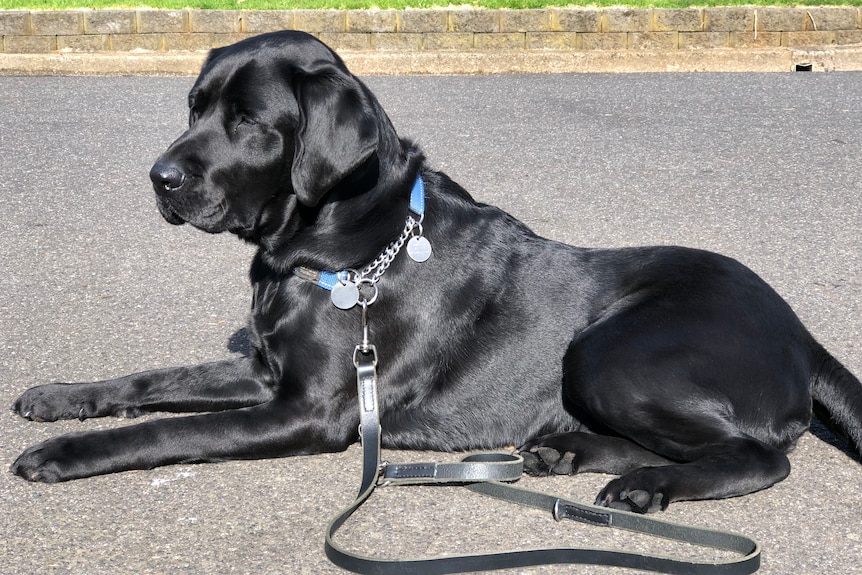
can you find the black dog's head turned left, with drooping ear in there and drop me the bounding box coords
[150,31,397,239]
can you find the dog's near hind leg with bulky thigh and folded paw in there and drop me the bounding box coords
[563,294,811,513]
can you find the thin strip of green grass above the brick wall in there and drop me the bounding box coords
[0,0,862,10]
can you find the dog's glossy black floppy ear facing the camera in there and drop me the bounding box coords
[291,62,378,206]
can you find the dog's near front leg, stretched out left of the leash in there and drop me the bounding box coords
[11,399,359,483]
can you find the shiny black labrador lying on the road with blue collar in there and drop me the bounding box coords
[12,31,862,512]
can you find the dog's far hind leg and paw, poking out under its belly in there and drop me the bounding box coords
[518,431,672,476]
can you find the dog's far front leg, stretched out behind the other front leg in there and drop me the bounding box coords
[12,358,273,421]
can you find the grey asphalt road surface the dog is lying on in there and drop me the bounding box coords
[0,73,862,575]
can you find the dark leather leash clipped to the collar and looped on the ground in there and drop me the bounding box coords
[325,346,760,575]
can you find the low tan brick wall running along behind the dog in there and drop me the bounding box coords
[0,7,862,54]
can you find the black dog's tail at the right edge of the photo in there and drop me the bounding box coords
[811,345,862,456]
